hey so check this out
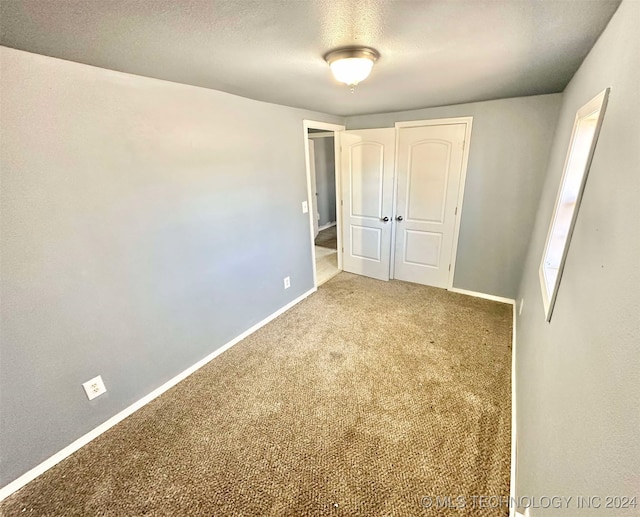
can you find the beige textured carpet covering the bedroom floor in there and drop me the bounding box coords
[0,273,512,517]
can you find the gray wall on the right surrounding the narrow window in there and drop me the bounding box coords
[516,1,640,510]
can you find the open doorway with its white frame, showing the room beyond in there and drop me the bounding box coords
[304,121,344,287]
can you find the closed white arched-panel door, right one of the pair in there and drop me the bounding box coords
[394,124,466,288]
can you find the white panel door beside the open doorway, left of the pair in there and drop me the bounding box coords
[340,128,395,280]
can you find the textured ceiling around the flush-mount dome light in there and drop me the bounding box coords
[0,0,620,115]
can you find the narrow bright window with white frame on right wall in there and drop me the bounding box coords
[540,88,609,321]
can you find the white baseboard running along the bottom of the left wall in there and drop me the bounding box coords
[0,287,317,501]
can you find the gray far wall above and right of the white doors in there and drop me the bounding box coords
[347,94,561,298]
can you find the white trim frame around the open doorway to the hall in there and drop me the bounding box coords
[302,119,345,289]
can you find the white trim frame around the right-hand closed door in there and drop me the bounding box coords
[389,117,473,289]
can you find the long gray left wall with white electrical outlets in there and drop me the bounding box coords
[0,48,342,486]
